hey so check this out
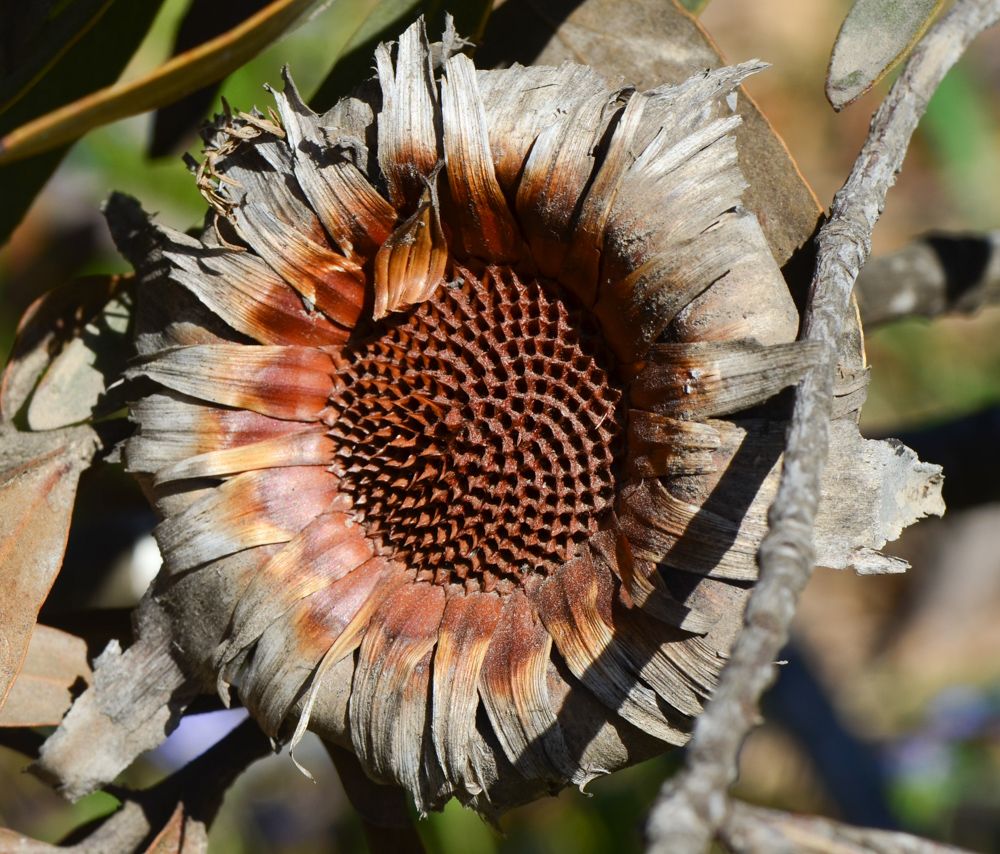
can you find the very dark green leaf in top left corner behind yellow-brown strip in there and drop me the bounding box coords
[0,0,162,245]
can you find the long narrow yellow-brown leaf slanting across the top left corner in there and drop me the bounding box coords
[0,0,344,164]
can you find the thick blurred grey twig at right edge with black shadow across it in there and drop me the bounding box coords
[854,231,1000,328]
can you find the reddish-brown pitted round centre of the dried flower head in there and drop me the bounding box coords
[326,267,624,592]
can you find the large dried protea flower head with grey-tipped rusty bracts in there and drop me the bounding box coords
[108,16,920,815]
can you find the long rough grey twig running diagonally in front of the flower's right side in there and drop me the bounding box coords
[647,0,1000,854]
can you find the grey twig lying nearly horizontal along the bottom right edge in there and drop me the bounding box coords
[719,801,968,854]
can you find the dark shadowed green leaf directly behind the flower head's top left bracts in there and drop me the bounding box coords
[309,0,492,112]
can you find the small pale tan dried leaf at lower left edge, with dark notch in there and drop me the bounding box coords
[0,625,92,726]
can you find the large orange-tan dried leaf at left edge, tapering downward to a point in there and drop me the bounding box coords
[0,428,96,707]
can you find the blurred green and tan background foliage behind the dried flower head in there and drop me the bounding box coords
[0,0,1000,854]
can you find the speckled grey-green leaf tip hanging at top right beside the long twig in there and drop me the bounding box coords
[826,0,943,110]
